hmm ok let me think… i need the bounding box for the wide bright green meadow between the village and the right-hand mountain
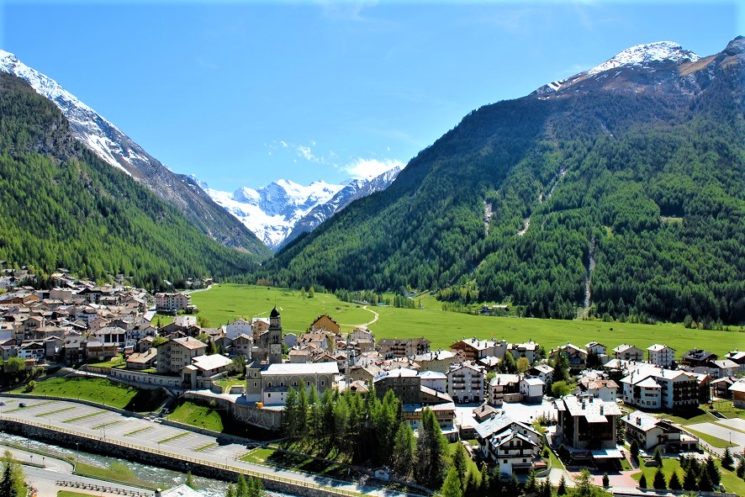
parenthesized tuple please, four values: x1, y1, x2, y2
(192, 284, 745, 356)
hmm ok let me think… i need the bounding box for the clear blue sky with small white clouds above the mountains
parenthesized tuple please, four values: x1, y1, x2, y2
(0, 0, 745, 190)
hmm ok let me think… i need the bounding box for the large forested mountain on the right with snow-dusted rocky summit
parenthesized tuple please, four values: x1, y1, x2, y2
(265, 37, 745, 322)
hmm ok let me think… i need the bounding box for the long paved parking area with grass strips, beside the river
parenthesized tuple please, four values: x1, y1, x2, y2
(0, 398, 406, 497)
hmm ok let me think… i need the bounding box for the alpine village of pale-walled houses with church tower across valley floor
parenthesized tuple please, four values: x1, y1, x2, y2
(0, 270, 745, 495)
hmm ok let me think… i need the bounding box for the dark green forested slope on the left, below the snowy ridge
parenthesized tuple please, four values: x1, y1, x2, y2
(0, 74, 255, 288)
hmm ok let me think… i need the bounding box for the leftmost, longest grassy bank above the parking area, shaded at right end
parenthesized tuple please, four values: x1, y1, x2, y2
(13, 377, 163, 412)
